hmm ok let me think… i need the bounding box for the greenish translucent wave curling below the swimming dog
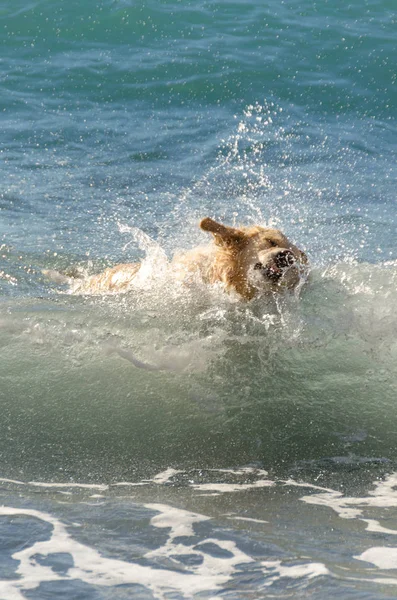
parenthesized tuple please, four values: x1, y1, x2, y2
(0, 247, 397, 480)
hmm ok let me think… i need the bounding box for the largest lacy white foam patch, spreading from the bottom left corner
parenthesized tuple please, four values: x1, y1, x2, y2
(0, 504, 329, 600)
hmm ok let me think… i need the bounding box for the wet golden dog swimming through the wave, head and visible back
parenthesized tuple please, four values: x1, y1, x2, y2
(55, 217, 308, 300)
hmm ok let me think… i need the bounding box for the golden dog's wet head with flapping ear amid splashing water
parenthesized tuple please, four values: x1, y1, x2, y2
(200, 217, 307, 300)
